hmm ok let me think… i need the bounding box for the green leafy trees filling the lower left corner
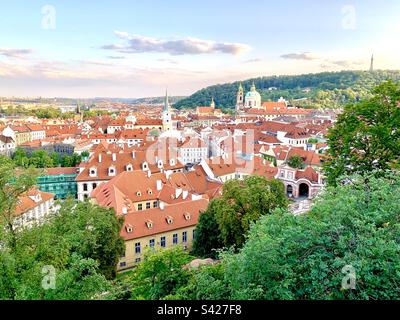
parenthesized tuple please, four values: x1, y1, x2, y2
(0, 157, 125, 299)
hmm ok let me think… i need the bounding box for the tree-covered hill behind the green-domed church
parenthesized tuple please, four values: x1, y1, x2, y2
(174, 70, 400, 109)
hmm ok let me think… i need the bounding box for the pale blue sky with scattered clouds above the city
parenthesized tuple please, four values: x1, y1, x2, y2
(0, 0, 400, 98)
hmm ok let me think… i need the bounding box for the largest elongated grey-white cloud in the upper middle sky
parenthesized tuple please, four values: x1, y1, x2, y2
(102, 31, 251, 55)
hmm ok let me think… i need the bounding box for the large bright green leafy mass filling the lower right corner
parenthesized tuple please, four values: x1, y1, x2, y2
(223, 173, 400, 300)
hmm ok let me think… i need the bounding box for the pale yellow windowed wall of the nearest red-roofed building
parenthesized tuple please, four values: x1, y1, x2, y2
(117, 226, 195, 271)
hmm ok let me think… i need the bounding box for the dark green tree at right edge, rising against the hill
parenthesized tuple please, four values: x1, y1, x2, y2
(325, 82, 400, 184)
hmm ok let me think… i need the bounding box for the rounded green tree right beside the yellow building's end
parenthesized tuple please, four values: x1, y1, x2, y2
(194, 176, 287, 252)
